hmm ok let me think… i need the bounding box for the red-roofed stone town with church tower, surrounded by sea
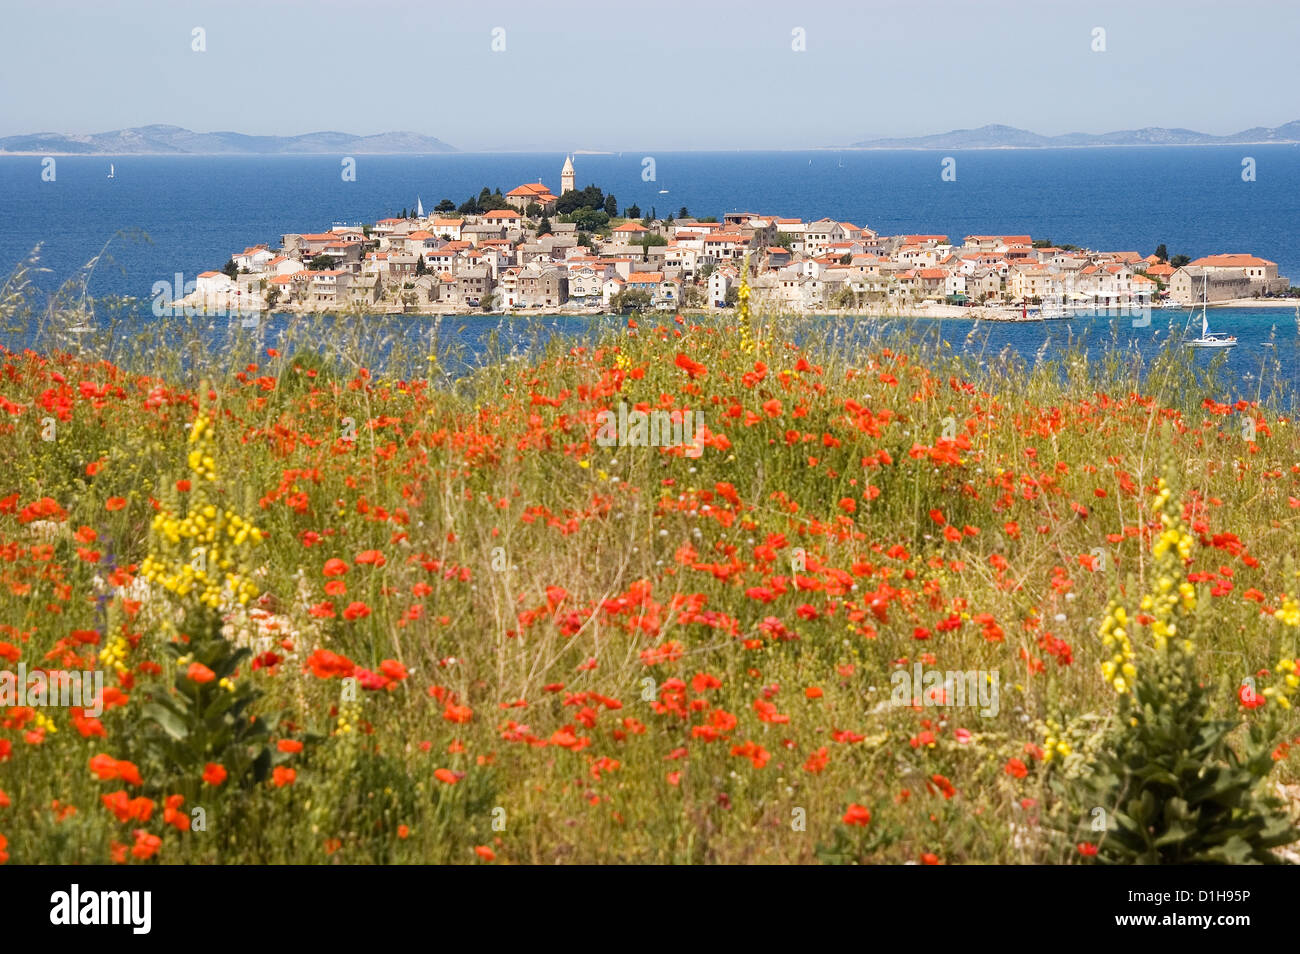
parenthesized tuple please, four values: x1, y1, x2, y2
(178, 157, 1300, 320)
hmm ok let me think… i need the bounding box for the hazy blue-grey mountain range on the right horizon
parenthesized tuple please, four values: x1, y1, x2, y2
(852, 120, 1300, 149)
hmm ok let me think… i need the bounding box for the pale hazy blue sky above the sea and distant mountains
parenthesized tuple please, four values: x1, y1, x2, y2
(0, 0, 1300, 151)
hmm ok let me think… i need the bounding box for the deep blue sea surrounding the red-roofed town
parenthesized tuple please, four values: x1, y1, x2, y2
(0, 146, 1300, 402)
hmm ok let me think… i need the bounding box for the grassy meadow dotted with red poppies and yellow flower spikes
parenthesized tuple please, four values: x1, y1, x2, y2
(0, 278, 1300, 864)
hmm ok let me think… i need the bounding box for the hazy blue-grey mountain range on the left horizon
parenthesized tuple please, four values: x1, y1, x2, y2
(0, 126, 456, 156)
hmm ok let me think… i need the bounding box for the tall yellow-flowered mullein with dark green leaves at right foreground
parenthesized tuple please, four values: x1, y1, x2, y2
(1048, 464, 1300, 864)
